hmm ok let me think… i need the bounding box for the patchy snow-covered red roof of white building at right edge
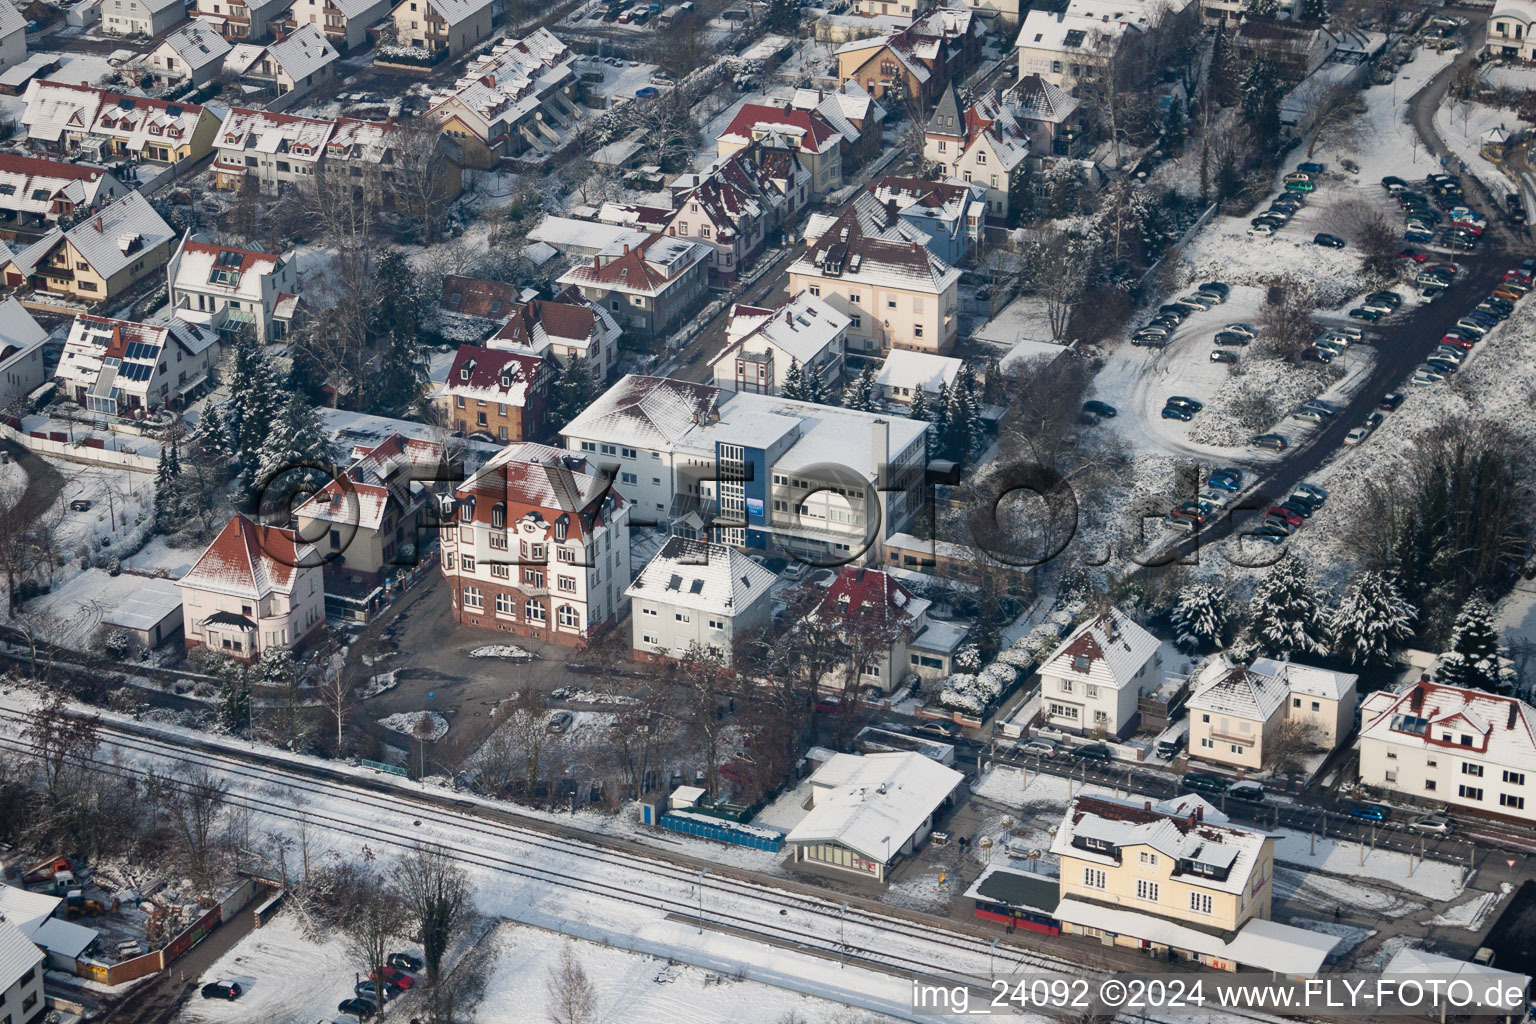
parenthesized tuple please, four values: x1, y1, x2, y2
(1359, 680, 1536, 771)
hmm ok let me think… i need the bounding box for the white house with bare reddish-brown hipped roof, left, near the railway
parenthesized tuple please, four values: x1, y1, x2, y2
(177, 513, 326, 662)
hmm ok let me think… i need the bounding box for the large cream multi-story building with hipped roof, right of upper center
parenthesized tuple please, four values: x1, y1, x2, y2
(790, 197, 960, 355)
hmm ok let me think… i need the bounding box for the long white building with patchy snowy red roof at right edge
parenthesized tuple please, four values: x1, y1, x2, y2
(1359, 679, 1536, 824)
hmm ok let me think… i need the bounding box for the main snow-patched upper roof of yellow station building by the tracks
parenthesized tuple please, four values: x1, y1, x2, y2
(1051, 797, 1269, 894)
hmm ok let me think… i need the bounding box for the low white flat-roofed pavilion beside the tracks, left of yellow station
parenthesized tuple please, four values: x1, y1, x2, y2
(785, 751, 965, 883)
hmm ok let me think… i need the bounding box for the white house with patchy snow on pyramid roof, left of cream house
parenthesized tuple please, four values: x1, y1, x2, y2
(1040, 608, 1163, 737)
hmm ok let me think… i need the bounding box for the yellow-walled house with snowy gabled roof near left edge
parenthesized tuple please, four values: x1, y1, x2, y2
(0, 192, 177, 304)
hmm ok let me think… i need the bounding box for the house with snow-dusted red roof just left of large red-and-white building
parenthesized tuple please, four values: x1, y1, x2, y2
(293, 434, 450, 583)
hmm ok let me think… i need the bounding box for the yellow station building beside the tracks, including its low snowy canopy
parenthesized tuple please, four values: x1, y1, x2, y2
(1051, 795, 1338, 976)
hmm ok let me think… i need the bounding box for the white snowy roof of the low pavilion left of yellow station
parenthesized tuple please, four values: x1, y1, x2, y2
(786, 751, 965, 864)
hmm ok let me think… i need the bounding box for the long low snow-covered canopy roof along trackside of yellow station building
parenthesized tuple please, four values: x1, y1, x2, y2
(1055, 897, 1339, 975)
